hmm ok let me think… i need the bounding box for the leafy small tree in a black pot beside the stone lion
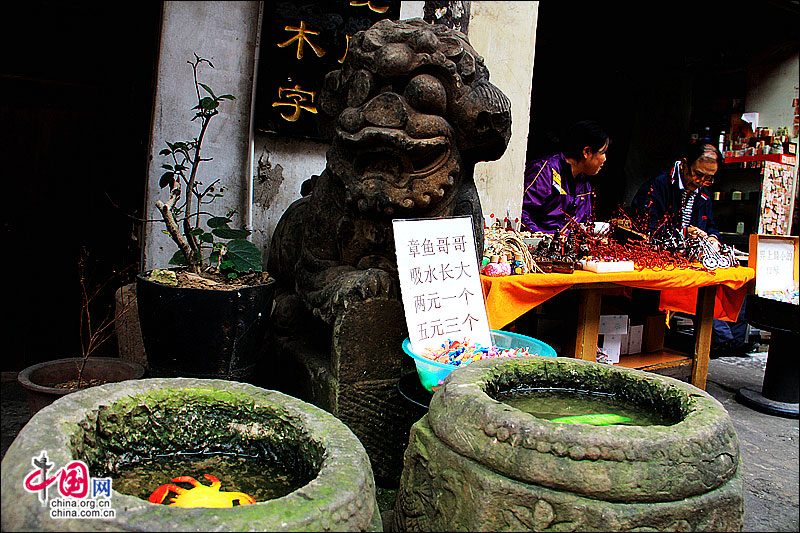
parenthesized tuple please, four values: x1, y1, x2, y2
(136, 54, 275, 380)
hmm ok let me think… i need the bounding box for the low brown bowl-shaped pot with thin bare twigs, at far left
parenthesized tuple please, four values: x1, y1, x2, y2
(17, 249, 145, 415)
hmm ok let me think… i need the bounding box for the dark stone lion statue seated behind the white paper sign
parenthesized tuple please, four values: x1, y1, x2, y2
(267, 19, 511, 324)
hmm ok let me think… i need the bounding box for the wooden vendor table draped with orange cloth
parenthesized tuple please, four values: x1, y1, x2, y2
(481, 266, 755, 389)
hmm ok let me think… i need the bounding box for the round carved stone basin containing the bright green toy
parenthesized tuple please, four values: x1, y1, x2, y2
(394, 358, 744, 531)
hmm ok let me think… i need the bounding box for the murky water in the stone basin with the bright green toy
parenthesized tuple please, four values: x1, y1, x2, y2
(495, 388, 676, 426)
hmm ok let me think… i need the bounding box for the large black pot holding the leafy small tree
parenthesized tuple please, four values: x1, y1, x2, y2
(136, 272, 276, 381)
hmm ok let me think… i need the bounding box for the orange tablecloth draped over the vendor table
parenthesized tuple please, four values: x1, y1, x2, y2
(481, 266, 755, 329)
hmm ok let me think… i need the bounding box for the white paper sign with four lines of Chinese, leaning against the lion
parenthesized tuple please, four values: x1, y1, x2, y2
(392, 216, 492, 353)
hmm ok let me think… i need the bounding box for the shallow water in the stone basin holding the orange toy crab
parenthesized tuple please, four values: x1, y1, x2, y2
(111, 454, 312, 504)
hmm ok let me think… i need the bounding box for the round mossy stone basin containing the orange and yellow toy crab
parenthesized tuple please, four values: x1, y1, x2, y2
(2, 378, 381, 531)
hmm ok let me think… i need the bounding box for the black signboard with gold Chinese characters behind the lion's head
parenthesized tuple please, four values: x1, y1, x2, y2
(255, 0, 400, 139)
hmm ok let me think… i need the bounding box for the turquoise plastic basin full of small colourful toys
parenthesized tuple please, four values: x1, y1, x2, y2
(403, 329, 557, 393)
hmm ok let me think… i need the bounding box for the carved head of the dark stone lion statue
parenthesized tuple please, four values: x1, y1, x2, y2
(319, 19, 511, 216)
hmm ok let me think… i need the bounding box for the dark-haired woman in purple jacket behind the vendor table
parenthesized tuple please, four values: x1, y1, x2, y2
(521, 120, 611, 233)
